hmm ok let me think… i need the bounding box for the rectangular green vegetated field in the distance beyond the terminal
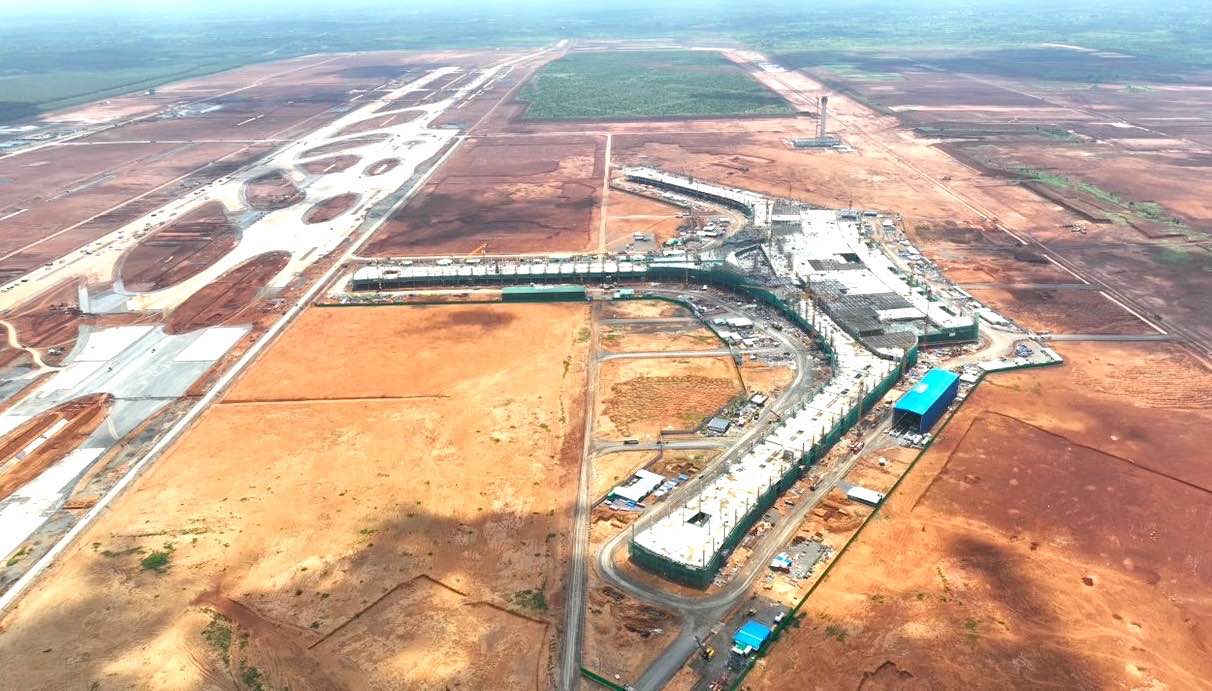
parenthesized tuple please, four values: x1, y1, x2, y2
(518, 51, 791, 120)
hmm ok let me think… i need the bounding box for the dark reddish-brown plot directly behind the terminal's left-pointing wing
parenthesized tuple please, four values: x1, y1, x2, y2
(364, 137, 604, 256)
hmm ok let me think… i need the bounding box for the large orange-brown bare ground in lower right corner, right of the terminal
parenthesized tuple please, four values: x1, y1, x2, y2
(748, 344, 1212, 690)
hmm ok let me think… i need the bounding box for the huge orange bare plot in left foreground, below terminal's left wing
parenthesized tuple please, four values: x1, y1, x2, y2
(0, 304, 588, 689)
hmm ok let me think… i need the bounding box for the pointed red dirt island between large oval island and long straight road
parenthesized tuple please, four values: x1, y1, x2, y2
(165, 252, 291, 333)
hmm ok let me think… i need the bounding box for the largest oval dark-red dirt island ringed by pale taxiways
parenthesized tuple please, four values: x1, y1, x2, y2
(121, 201, 238, 292)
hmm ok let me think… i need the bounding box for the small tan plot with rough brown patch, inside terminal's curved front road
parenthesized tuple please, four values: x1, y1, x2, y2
(594, 358, 742, 439)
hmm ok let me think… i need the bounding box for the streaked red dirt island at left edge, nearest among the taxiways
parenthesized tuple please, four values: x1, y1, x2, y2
(0, 394, 113, 499)
